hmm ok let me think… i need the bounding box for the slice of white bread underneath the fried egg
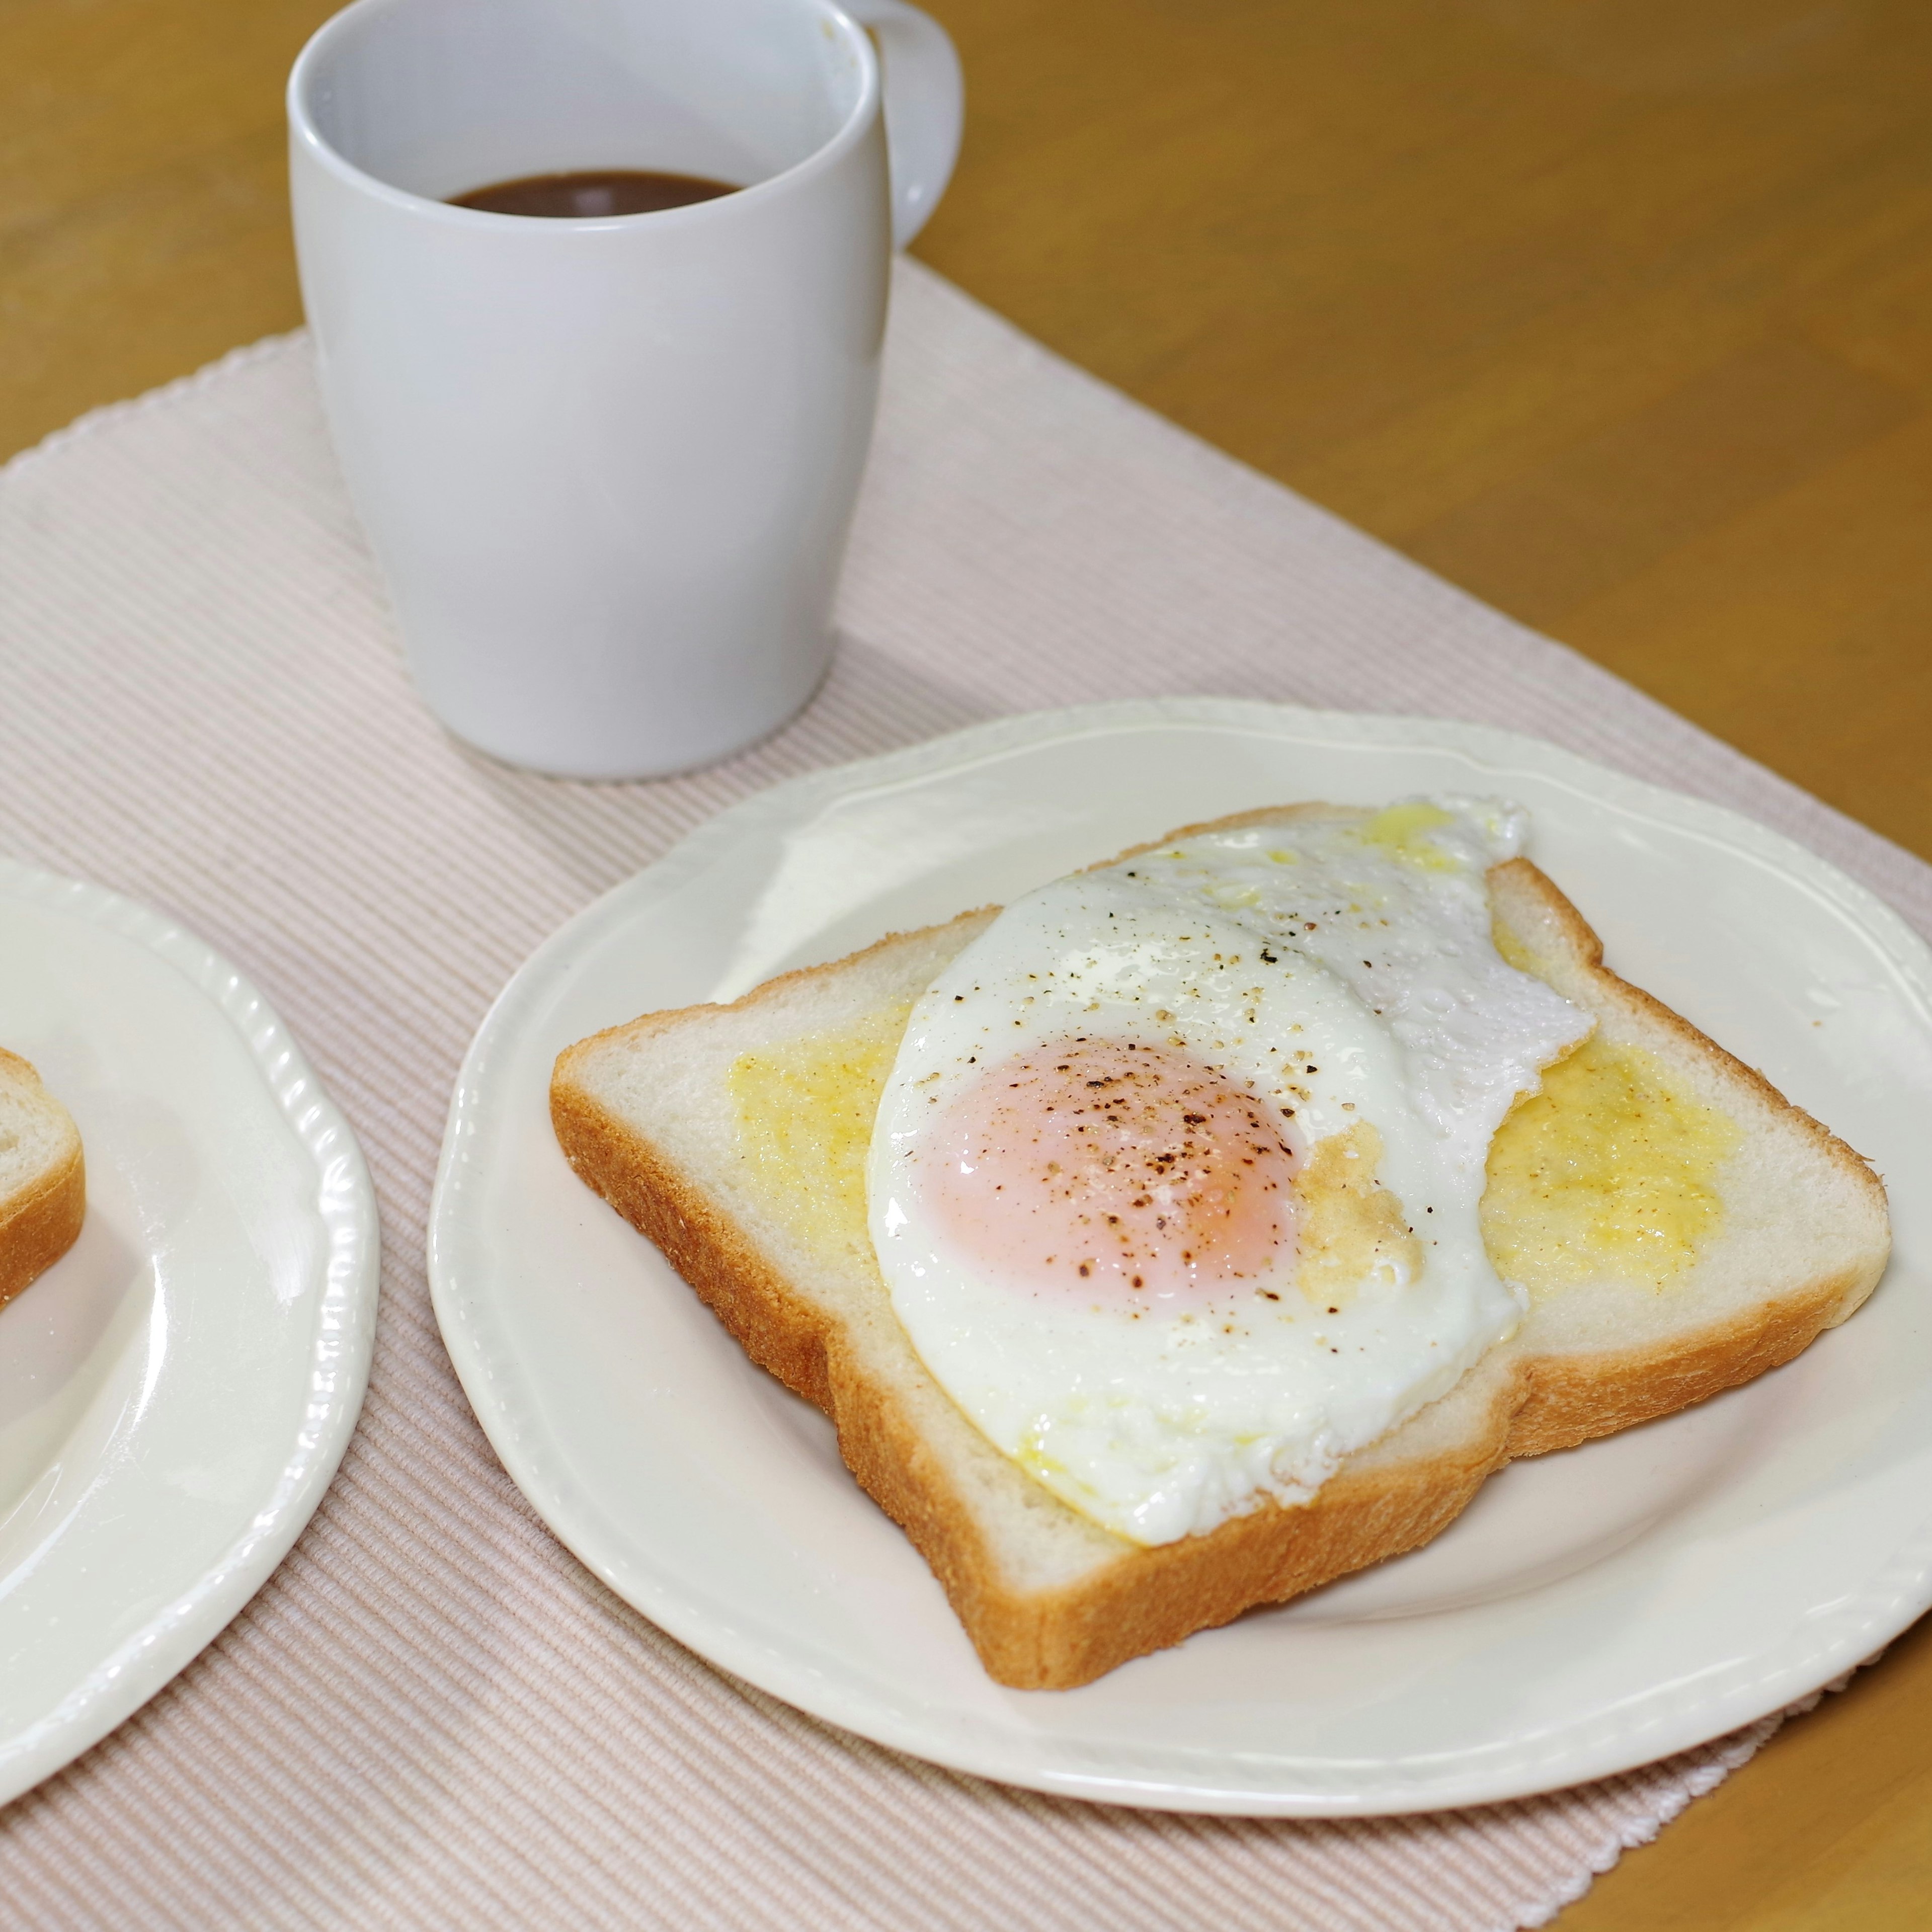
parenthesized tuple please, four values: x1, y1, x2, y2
(550, 808, 1890, 1688)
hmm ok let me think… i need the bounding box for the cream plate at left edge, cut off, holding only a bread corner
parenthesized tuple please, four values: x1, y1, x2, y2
(0, 860, 377, 1801)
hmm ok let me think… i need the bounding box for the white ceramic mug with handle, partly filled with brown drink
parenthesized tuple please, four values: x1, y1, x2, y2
(288, 0, 960, 777)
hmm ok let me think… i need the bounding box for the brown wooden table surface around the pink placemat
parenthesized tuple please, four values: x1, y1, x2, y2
(0, 0, 1932, 1932)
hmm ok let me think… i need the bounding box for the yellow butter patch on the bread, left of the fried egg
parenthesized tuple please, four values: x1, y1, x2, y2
(727, 1003, 912, 1244)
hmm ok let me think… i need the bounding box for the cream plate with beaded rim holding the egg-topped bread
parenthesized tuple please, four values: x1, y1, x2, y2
(431, 699, 1932, 1816)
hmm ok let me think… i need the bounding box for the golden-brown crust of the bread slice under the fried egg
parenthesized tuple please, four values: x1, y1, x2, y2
(550, 823, 1886, 1688)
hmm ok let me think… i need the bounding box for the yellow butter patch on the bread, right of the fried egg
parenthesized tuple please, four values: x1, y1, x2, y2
(1482, 1035, 1743, 1295)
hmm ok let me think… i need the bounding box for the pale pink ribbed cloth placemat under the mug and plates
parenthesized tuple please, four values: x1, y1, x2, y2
(0, 265, 1932, 1932)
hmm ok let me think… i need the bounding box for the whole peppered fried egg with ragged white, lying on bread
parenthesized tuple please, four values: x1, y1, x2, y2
(867, 798, 1592, 1546)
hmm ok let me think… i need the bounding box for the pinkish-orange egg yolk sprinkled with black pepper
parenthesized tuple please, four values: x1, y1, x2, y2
(920, 1039, 1298, 1304)
